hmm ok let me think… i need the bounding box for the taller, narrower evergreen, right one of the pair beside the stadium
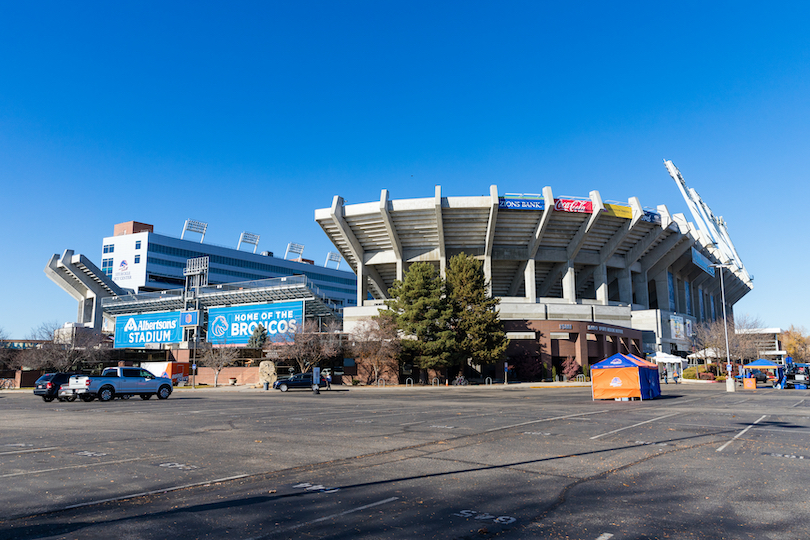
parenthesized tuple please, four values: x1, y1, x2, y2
(447, 253, 508, 365)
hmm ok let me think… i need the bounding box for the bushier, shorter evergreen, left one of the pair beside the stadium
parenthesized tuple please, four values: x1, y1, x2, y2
(386, 262, 457, 369)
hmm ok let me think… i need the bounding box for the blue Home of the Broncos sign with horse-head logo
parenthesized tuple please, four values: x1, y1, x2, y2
(208, 302, 304, 345)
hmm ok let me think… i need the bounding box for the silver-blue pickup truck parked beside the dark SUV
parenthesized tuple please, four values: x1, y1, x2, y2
(59, 367, 172, 401)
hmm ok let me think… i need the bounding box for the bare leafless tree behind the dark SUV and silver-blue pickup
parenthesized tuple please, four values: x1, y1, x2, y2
(15, 322, 109, 371)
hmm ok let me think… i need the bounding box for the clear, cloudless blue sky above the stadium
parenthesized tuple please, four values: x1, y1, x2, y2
(0, 1, 810, 337)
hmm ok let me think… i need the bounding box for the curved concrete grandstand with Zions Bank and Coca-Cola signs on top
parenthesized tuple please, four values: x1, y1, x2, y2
(315, 162, 753, 373)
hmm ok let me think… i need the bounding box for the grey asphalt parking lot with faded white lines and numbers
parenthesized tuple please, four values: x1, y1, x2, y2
(0, 385, 810, 540)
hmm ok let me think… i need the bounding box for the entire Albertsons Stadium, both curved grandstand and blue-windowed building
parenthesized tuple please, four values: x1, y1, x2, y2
(38, 162, 753, 384)
